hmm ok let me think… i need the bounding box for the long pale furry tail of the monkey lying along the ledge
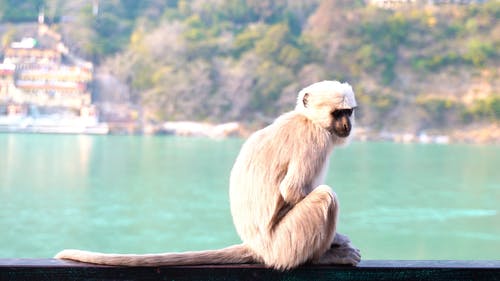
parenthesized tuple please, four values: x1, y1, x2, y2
(55, 244, 256, 266)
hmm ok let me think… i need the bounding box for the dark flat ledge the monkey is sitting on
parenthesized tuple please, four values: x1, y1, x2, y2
(0, 259, 500, 281)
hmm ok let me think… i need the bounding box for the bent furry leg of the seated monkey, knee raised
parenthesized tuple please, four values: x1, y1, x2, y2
(258, 185, 338, 269)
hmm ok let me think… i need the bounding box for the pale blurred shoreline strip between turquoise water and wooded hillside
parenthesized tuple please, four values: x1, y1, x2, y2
(0, 121, 500, 145)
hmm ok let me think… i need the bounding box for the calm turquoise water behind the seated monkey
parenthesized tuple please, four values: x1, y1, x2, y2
(0, 134, 500, 259)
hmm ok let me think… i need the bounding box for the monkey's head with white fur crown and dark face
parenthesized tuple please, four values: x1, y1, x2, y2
(295, 81, 357, 138)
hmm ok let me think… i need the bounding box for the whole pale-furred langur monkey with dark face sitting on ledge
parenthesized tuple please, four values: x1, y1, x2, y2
(56, 81, 361, 270)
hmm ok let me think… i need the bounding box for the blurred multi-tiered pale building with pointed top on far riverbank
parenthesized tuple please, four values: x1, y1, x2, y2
(0, 23, 107, 132)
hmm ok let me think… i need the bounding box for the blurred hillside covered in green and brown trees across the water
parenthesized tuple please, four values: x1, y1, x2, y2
(0, 0, 500, 142)
